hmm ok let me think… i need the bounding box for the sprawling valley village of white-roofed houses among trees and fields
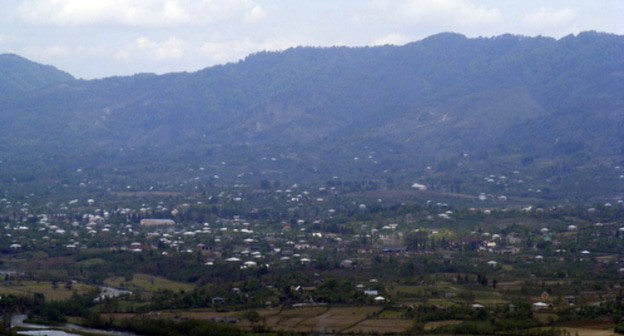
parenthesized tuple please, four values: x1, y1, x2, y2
(0, 181, 624, 333)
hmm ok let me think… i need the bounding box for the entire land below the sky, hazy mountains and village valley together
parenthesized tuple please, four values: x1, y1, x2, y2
(0, 32, 624, 336)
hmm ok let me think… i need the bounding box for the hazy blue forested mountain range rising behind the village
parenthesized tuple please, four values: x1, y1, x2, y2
(0, 32, 624, 200)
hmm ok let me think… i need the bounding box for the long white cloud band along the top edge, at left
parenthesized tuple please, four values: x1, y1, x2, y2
(17, 0, 266, 27)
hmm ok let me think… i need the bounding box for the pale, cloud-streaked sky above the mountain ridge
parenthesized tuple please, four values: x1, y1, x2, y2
(0, 0, 624, 79)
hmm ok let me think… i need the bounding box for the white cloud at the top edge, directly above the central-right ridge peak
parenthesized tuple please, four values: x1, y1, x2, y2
(399, 0, 501, 25)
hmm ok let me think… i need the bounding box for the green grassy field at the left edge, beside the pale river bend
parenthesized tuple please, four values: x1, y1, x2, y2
(0, 281, 96, 301)
